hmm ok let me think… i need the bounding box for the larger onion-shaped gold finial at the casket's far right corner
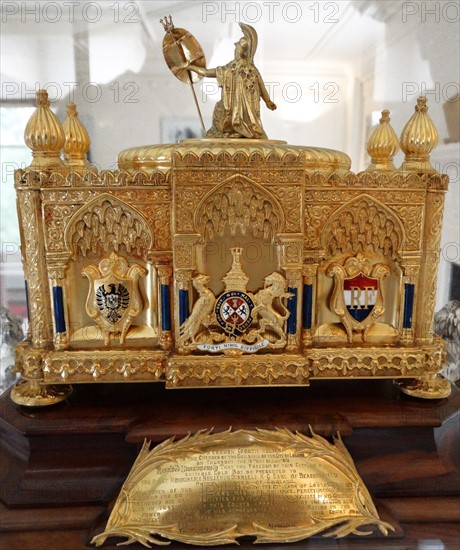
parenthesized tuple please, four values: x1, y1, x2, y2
(399, 97, 438, 172)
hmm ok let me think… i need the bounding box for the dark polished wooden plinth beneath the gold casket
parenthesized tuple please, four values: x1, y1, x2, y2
(0, 380, 460, 550)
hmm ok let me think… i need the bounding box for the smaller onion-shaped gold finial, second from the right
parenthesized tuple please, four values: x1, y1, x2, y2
(366, 109, 399, 172)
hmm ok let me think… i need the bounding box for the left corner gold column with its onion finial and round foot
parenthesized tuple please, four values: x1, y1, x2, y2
(11, 90, 72, 406)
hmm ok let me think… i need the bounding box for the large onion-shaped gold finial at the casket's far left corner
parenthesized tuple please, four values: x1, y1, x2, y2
(24, 90, 65, 168)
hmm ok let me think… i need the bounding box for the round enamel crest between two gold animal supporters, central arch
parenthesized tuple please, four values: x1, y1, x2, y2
(215, 290, 254, 336)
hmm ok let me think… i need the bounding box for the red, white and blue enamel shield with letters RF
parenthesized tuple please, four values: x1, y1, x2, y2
(343, 273, 379, 323)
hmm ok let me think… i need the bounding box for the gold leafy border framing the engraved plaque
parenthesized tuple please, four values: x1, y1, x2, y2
(91, 428, 394, 547)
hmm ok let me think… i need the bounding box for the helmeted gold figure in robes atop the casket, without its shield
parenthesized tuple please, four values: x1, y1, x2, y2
(185, 23, 276, 139)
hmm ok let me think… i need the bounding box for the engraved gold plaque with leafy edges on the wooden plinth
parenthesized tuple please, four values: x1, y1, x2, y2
(92, 429, 393, 546)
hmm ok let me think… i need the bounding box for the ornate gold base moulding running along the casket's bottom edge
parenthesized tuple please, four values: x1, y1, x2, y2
(30, 338, 444, 387)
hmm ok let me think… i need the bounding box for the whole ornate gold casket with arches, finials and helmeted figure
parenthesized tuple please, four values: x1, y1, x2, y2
(8, 18, 450, 406)
